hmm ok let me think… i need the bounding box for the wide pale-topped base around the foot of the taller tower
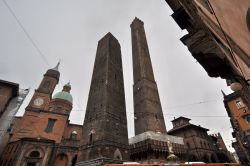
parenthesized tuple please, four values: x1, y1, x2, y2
(129, 131, 187, 164)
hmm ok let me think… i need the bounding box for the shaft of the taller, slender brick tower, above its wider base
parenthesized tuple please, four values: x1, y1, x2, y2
(130, 18, 166, 135)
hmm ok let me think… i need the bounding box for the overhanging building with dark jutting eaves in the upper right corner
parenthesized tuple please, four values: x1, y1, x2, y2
(166, 0, 250, 86)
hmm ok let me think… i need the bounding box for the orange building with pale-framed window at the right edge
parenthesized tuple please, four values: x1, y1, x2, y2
(224, 89, 250, 165)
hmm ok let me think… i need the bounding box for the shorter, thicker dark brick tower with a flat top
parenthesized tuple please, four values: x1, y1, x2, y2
(78, 33, 128, 165)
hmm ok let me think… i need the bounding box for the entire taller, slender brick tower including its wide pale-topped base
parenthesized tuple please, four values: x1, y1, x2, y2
(129, 18, 184, 163)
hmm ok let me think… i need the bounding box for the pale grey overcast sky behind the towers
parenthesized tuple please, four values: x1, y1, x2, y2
(0, 0, 233, 150)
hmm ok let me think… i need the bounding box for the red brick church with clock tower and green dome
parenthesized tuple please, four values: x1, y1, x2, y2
(0, 64, 82, 166)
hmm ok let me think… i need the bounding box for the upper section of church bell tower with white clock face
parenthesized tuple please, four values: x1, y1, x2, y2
(26, 62, 60, 111)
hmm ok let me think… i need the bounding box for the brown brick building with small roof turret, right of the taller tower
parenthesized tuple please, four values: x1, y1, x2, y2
(168, 117, 234, 163)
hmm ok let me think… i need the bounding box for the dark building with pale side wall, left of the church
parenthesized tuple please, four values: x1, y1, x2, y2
(0, 80, 29, 155)
